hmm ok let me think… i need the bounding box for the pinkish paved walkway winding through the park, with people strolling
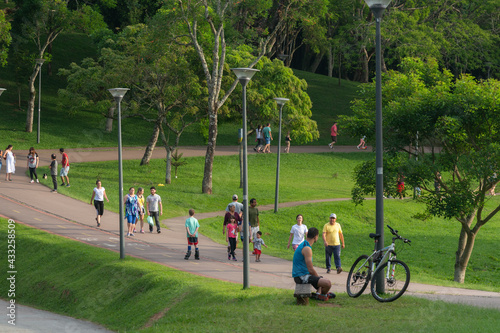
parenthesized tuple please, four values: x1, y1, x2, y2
(0, 147, 500, 332)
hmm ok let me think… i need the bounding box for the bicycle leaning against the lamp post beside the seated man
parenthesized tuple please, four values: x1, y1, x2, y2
(347, 226, 411, 302)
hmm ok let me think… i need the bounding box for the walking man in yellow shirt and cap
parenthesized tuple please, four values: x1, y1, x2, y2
(323, 214, 345, 274)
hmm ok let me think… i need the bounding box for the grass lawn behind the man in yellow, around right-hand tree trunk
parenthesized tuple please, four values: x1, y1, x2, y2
(200, 197, 500, 292)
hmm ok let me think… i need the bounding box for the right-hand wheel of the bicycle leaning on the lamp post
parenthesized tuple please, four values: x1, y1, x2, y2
(370, 260, 410, 302)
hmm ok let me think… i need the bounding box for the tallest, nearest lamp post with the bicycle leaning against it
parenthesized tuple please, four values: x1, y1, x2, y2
(365, 0, 391, 292)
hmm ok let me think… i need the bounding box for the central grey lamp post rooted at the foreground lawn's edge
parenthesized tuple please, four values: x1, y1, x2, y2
(231, 68, 259, 289)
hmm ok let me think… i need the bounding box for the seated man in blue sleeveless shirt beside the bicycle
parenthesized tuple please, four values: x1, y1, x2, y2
(292, 228, 335, 301)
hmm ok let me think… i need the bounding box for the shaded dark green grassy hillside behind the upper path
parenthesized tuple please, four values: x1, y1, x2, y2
(0, 34, 358, 149)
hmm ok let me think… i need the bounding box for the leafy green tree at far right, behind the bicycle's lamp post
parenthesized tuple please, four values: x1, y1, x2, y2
(341, 58, 500, 283)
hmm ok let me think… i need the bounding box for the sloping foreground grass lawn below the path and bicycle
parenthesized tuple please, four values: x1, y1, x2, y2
(0, 219, 500, 333)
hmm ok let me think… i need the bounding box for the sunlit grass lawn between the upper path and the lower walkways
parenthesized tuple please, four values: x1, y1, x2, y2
(34, 153, 373, 217)
